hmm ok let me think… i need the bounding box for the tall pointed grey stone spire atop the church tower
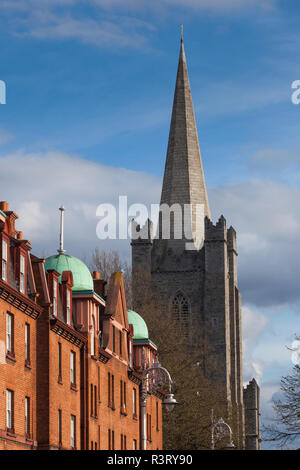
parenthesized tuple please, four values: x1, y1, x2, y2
(161, 32, 210, 228)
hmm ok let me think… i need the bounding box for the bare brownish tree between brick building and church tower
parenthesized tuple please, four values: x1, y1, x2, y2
(91, 249, 232, 450)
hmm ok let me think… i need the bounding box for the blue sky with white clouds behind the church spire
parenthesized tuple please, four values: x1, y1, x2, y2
(0, 0, 300, 448)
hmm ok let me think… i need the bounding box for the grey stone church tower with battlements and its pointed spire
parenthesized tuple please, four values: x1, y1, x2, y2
(131, 38, 260, 448)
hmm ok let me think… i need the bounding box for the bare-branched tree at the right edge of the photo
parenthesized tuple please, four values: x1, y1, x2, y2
(263, 365, 300, 447)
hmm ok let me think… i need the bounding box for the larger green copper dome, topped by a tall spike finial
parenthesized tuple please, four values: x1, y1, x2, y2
(44, 254, 94, 291)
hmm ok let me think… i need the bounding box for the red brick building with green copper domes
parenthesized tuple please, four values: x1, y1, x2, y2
(0, 202, 164, 450)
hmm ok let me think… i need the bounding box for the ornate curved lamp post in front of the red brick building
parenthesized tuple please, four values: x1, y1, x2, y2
(140, 361, 178, 450)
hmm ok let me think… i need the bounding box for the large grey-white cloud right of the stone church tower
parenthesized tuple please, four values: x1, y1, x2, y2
(209, 180, 300, 306)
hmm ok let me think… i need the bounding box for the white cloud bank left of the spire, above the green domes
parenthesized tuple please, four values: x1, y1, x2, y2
(0, 152, 161, 256)
